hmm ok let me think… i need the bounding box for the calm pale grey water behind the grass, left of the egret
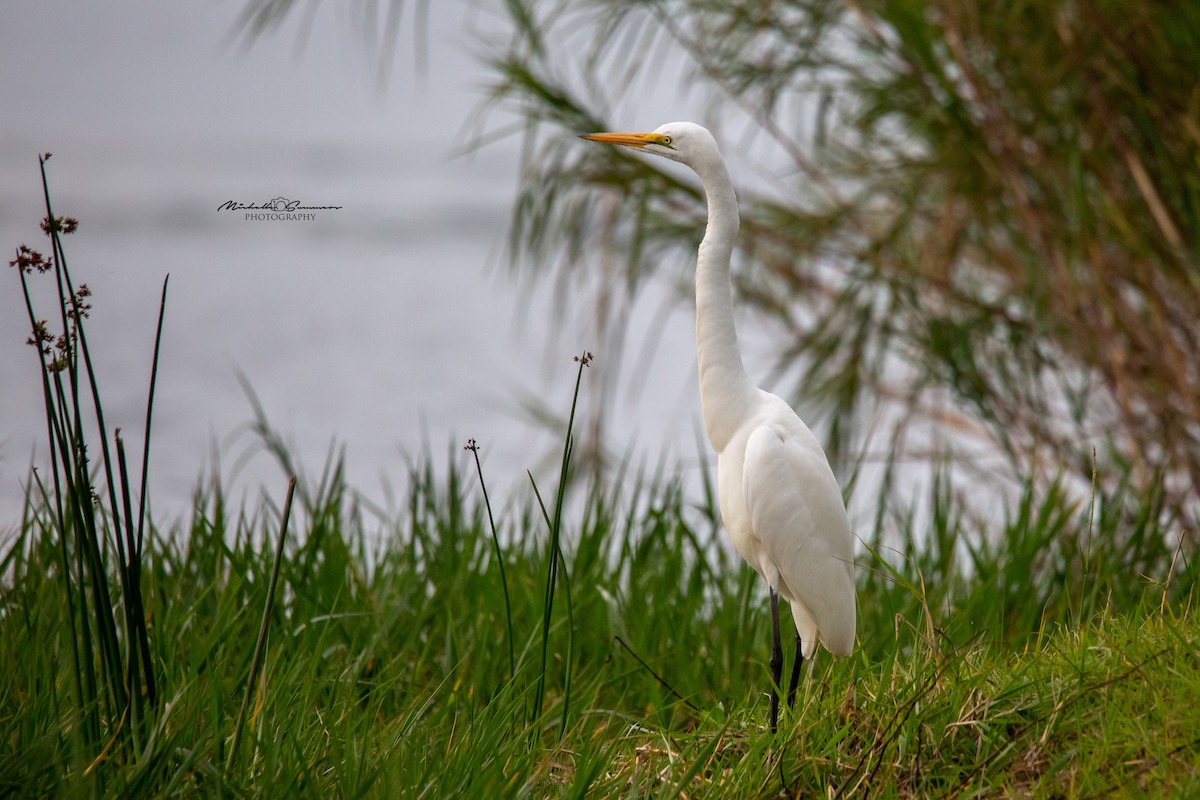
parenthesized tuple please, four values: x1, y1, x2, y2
(0, 128, 698, 527)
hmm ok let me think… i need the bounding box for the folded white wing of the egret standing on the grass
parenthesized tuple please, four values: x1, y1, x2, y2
(743, 420, 854, 655)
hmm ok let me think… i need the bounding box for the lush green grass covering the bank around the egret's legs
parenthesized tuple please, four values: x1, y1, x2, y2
(0, 441, 1200, 798)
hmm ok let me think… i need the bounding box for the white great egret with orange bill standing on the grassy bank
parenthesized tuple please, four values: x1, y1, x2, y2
(583, 122, 854, 733)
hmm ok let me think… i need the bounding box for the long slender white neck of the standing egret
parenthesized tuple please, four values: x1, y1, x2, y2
(695, 153, 757, 453)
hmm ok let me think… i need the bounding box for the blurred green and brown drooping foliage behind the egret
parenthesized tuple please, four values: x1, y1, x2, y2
(246, 0, 1200, 527)
